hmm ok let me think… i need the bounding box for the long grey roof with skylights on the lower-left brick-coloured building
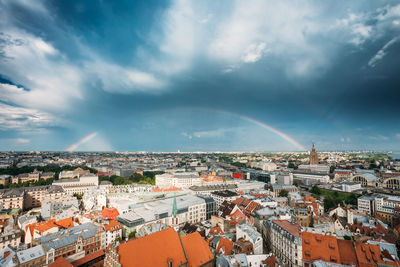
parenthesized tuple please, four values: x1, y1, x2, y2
(36, 223, 99, 250)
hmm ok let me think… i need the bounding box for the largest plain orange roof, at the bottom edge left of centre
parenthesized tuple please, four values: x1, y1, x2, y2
(118, 228, 187, 267)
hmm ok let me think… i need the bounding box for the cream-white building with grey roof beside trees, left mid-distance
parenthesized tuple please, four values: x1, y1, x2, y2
(53, 175, 99, 194)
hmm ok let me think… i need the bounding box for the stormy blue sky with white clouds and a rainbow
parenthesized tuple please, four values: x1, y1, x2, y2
(0, 0, 400, 151)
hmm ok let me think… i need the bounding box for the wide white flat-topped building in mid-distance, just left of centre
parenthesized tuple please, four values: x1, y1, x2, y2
(156, 172, 201, 188)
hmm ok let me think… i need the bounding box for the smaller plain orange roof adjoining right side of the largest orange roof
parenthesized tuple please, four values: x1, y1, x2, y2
(182, 232, 214, 266)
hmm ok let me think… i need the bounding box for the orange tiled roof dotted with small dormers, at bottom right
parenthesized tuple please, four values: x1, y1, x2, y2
(301, 232, 341, 264)
